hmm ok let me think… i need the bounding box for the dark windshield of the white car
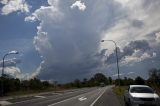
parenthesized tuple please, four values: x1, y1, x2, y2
(130, 87, 153, 93)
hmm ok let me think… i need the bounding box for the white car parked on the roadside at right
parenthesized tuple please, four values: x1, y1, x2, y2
(124, 85, 160, 106)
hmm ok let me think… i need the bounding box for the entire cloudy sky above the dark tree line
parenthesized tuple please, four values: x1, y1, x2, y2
(0, 0, 160, 82)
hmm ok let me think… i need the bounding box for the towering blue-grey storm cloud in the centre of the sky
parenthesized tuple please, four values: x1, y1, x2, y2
(26, 0, 125, 81)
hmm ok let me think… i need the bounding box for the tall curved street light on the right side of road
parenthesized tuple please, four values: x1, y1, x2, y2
(101, 40, 120, 86)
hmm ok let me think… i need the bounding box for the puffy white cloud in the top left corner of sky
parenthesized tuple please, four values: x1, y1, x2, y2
(0, 0, 29, 15)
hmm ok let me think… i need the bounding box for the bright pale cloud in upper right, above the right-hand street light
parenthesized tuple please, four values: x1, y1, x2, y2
(104, 0, 160, 48)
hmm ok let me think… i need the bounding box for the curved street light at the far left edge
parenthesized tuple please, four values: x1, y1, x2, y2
(1, 51, 19, 96)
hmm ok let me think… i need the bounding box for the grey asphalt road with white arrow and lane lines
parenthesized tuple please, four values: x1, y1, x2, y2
(0, 86, 121, 106)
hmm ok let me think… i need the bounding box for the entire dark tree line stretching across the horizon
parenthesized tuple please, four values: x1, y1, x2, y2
(0, 68, 160, 94)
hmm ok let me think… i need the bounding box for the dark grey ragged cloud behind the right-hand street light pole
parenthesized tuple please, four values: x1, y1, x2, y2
(105, 40, 153, 64)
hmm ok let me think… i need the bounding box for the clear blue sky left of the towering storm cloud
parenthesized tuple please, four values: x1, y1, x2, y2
(0, 0, 47, 73)
